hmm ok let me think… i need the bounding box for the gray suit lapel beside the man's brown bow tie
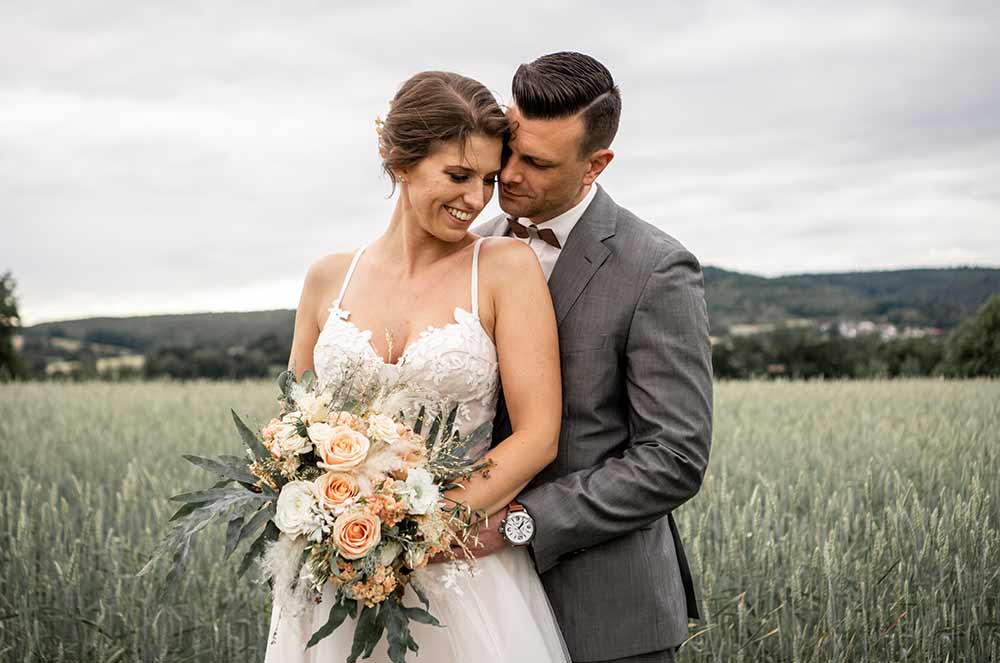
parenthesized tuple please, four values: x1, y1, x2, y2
(549, 185, 618, 324)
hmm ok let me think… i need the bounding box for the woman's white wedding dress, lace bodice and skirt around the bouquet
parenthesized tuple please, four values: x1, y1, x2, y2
(265, 239, 570, 663)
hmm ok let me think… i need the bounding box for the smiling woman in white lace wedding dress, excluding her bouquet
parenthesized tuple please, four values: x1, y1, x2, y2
(266, 72, 569, 663)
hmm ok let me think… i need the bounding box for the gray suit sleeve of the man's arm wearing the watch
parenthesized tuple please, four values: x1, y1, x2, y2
(518, 249, 712, 573)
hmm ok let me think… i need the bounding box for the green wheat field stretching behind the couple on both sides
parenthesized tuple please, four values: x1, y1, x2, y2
(0, 380, 1000, 663)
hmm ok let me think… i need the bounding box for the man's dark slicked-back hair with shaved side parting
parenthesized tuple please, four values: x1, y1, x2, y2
(511, 51, 622, 157)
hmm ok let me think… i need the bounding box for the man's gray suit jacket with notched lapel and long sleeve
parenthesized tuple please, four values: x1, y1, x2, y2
(474, 189, 712, 661)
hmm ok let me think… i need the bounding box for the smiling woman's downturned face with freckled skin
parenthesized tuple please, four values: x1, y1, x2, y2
(400, 135, 503, 242)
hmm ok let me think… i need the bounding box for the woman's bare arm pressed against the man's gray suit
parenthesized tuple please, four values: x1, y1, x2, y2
(446, 238, 562, 514)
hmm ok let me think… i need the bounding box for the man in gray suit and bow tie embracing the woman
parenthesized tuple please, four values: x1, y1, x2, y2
(474, 53, 712, 663)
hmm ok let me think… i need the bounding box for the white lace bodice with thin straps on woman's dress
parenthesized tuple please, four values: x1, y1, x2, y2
(313, 238, 500, 452)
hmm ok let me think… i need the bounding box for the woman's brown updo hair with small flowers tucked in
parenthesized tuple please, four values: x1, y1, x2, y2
(376, 71, 511, 191)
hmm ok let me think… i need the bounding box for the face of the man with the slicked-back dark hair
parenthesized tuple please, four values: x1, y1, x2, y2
(500, 105, 590, 223)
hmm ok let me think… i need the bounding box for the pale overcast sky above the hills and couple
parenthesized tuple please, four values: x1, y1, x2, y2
(0, 0, 1000, 325)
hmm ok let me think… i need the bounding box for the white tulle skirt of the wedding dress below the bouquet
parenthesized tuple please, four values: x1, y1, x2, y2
(265, 548, 570, 663)
